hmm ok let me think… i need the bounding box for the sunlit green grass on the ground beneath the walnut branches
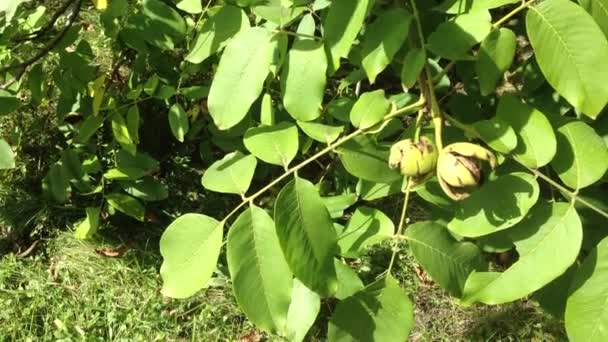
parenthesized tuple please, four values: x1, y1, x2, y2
(0, 227, 565, 341)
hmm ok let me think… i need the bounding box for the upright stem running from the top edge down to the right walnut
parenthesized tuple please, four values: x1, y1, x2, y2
(410, 0, 443, 151)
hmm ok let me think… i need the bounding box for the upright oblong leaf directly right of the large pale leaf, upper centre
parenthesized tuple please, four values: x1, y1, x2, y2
(281, 39, 327, 121)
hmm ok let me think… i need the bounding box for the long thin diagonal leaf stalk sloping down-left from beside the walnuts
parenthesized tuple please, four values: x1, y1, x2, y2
(222, 97, 426, 223)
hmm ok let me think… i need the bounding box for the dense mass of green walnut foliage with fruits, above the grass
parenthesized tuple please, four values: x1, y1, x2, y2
(0, 0, 608, 341)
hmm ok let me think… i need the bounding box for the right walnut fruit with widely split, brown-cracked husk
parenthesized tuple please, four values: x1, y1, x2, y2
(437, 143, 496, 201)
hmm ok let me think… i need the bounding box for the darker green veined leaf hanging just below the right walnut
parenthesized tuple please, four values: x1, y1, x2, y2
(405, 221, 488, 297)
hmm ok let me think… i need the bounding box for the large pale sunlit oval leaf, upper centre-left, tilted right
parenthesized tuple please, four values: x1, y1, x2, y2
(208, 27, 276, 130)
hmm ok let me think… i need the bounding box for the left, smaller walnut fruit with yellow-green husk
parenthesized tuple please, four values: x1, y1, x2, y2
(388, 137, 439, 181)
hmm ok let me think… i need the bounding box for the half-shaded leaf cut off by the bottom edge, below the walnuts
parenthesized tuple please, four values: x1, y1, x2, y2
(327, 275, 414, 342)
